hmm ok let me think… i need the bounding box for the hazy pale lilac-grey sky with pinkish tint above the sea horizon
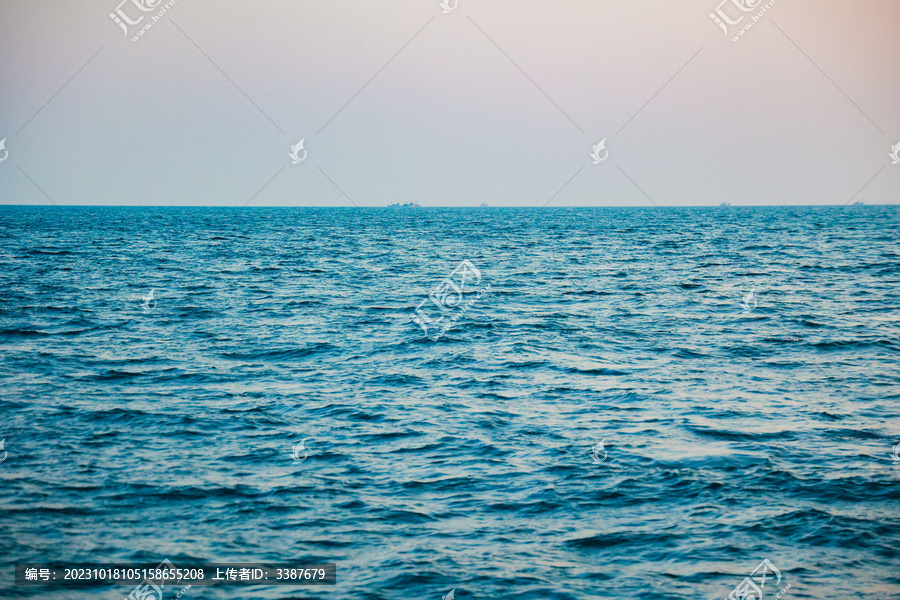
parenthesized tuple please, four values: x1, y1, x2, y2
(0, 0, 900, 207)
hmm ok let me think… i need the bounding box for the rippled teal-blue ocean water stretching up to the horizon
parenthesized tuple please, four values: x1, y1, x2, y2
(0, 206, 900, 600)
